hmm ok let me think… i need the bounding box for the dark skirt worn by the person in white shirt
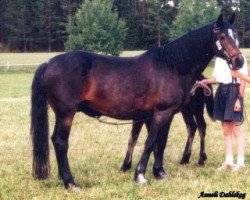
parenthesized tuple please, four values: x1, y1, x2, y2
(213, 84, 243, 122)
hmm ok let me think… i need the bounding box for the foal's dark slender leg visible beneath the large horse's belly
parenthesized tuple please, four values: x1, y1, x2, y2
(120, 122, 143, 172)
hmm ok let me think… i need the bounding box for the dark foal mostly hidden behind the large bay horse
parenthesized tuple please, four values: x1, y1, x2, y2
(121, 75, 214, 172)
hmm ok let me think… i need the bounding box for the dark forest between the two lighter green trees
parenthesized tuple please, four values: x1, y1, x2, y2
(114, 0, 178, 49)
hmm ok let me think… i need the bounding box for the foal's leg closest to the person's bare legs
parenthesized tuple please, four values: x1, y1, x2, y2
(195, 114, 207, 166)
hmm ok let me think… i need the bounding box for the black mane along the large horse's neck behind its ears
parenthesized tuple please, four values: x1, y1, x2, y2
(147, 23, 214, 73)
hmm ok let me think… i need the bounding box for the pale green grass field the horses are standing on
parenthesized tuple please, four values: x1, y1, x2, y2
(0, 49, 250, 200)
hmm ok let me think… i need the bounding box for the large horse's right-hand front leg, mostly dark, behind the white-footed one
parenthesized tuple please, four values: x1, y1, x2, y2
(153, 117, 173, 179)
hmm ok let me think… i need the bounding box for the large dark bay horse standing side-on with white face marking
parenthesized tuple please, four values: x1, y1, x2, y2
(31, 15, 244, 189)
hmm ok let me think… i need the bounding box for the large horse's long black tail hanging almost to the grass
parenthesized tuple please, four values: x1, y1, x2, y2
(30, 63, 50, 179)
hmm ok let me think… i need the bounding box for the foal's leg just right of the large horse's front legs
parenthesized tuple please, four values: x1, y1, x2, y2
(180, 108, 197, 165)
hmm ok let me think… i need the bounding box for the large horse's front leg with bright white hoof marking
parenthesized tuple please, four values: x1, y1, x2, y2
(135, 111, 172, 184)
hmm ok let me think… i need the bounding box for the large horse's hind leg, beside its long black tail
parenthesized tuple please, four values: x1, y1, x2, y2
(52, 114, 77, 190)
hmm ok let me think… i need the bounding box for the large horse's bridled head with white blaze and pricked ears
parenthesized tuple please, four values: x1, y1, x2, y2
(213, 14, 244, 70)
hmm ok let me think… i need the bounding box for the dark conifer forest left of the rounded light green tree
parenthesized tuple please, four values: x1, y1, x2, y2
(0, 0, 82, 52)
